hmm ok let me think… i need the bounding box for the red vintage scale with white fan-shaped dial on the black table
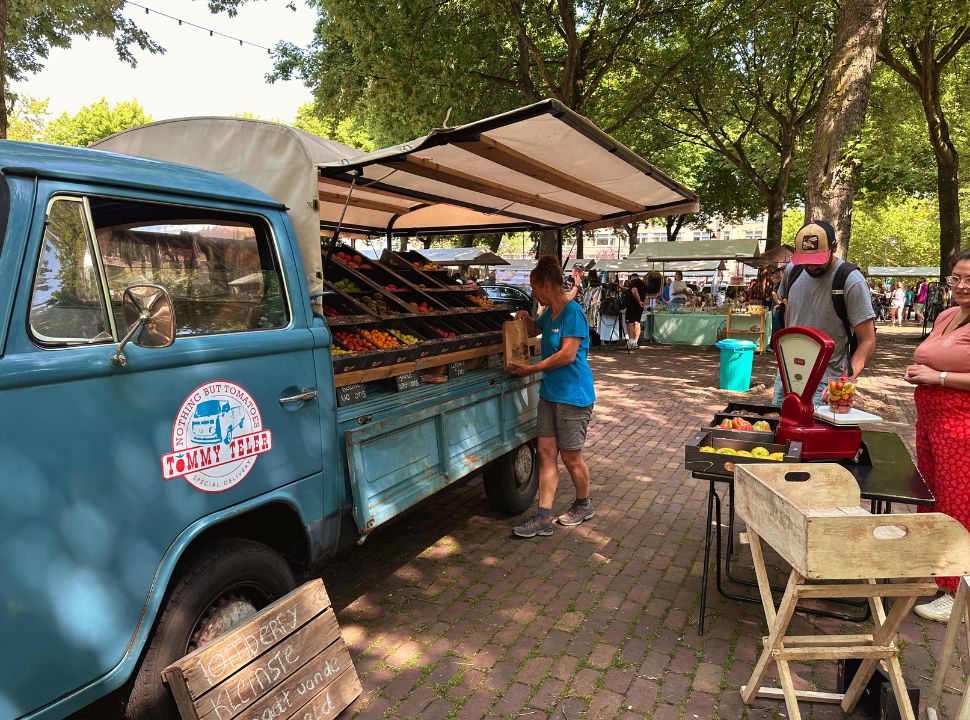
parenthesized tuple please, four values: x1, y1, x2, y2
(774, 326, 862, 460)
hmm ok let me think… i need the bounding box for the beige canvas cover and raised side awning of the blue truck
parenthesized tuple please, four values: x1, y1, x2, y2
(94, 100, 698, 290)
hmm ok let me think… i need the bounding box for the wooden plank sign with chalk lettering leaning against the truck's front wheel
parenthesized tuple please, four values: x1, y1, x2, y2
(162, 580, 361, 720)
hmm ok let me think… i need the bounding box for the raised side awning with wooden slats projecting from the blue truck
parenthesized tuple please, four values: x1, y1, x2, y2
(319, 100, 698, 235)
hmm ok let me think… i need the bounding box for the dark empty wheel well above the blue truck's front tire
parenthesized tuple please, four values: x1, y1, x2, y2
(180, 503, 310, 577)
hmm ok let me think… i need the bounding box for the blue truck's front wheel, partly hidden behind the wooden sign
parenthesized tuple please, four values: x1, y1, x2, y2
(125, 538, 295, 720)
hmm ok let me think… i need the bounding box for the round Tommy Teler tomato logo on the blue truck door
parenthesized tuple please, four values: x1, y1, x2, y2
(162, 380, 273, 492)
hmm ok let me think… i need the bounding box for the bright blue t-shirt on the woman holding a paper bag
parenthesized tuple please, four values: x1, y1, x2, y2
(536, 302, 596, 407)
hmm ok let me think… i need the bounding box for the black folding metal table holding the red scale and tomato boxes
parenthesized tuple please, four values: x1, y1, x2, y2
(691, 430, 936, 635)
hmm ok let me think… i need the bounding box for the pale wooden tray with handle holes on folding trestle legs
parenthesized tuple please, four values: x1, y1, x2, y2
(734, 463, 970, 720)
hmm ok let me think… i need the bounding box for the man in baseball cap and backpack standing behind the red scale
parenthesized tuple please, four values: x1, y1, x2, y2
(773, 220, 876, 405)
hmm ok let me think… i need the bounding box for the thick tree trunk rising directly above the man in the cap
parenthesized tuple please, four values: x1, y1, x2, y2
(805, 0, 888, 254)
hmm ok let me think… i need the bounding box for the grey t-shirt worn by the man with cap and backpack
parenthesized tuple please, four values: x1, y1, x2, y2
(778, 260, 876, 380)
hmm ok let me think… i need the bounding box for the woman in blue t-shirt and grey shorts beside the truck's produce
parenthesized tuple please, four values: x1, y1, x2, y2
(509, 255, 596, 537)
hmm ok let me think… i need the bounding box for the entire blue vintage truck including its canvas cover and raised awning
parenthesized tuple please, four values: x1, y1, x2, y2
(0, 100, 697, 720)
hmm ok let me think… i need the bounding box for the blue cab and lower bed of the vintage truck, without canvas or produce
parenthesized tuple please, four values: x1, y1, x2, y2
(0, 142, 537, 720)
